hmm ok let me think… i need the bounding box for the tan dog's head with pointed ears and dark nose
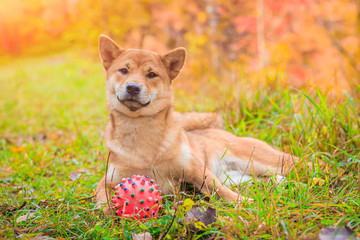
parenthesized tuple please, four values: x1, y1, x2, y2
(99, 35, 186, 117)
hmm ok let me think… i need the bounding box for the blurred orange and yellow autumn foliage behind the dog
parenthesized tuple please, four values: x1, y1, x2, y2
(0, 0, 360, 95)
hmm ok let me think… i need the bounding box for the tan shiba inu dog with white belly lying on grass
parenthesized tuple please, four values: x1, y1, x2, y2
(96, 35, 298, 211)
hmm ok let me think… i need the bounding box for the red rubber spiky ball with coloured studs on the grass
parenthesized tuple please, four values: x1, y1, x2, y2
(112, 175, 162, 220)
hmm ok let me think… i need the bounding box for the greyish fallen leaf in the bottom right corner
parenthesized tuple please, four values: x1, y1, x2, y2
(319, 227, 358, 240)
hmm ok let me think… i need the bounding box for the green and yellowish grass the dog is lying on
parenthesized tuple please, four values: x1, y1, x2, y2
(0, 51, 360, 239)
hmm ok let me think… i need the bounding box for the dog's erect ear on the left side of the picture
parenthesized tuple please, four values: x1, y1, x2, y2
(99, 34, 125, 70)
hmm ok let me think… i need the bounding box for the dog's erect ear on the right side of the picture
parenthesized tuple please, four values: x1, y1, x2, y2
(163, 47, 186, 81)
